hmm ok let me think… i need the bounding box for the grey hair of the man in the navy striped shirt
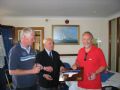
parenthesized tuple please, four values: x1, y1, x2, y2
(20, 27, 34, 40)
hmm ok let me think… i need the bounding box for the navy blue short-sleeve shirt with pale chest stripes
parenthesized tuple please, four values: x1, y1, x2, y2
(8, 44, 36, 88)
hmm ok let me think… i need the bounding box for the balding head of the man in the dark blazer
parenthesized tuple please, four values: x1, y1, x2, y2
(43, 38, 54, 51)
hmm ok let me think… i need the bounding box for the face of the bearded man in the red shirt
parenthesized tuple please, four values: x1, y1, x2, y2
(82, 34, 92, 48)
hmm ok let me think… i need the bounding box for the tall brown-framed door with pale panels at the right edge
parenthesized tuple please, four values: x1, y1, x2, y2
(109, 18, 120, 72)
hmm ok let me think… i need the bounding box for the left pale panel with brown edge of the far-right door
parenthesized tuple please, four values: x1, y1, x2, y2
(109, 19, 117, 71)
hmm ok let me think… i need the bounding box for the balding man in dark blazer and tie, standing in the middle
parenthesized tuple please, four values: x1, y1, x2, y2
(36, 38, 64, 90)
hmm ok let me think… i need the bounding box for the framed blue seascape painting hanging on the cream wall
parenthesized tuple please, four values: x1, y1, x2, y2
(52, 25, 80, 45)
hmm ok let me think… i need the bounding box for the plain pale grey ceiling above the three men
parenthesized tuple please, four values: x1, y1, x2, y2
(0, 0, 120, 17)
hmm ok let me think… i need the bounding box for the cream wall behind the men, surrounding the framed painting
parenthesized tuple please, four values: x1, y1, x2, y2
(1, 17, 108, 64)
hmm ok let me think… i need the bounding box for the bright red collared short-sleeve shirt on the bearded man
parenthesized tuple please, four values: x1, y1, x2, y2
(76, 46, 107, 89)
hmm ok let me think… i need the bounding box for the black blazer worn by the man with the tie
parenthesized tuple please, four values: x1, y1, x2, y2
(36, 50, 63, 88)
